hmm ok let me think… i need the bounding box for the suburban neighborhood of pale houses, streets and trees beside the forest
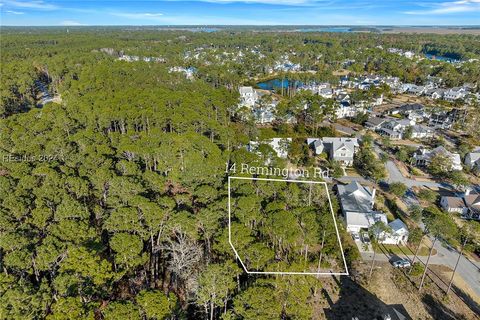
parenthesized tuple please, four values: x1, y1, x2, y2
(236, 42, 480, 316)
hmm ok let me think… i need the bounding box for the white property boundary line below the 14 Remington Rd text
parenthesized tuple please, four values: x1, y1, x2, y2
(228, 176, 349, 276)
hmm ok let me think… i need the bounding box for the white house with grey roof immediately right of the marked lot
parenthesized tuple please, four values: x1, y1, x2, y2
(337, 181, 388, 233)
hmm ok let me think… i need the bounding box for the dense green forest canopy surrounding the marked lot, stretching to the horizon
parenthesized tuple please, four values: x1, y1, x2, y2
(0, 27, 480, 319)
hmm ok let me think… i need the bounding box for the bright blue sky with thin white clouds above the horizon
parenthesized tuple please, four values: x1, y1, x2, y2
(0, 0, 480, 26)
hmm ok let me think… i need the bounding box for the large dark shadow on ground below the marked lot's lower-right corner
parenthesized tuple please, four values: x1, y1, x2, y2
(322, 276, 412, 320)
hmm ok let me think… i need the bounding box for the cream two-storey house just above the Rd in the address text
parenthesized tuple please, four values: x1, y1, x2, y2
(307, 137, 359, 166)
